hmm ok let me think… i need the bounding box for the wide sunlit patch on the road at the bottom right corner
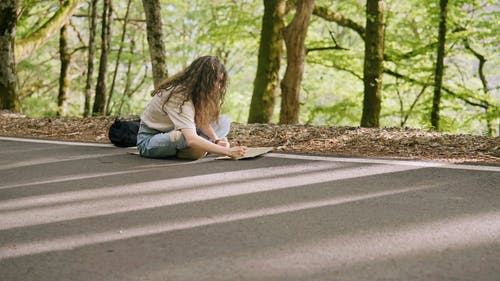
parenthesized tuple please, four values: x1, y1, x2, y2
(146, 211, 500, 280)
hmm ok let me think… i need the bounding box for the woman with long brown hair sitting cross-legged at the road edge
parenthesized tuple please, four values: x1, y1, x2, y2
(137, 56, 246, 160)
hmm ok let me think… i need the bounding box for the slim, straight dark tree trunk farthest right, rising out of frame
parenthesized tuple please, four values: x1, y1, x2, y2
(431, 0, 448, 131)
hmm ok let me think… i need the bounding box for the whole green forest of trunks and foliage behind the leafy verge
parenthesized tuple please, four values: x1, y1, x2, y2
(0, 0, 500, 136)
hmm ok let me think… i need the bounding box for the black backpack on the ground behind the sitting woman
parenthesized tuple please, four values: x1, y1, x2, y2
(108, 118, 141, 147)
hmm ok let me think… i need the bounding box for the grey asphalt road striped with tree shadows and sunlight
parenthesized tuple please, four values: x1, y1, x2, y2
(0, 138, 500, 281)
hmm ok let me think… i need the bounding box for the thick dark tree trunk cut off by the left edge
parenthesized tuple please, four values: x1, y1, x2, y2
(0, 0, 20, 112)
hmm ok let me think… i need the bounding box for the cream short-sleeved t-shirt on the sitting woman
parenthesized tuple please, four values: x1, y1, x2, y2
(141, 90, 196, 132)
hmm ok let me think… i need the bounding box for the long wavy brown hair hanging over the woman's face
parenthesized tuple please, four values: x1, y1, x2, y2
(151, 56, 228, 127)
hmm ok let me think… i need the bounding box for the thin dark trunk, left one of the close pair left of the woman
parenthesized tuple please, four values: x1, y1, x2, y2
(83, 0, 98, 117)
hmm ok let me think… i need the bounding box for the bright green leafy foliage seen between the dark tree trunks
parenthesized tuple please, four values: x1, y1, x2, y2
(13, 0, 500, 134)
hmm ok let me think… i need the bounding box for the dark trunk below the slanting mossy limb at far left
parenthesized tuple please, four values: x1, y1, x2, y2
(57, 18, 71, 116)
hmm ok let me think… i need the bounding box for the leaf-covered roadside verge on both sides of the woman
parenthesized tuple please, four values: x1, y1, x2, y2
(0, 112, 500, 165)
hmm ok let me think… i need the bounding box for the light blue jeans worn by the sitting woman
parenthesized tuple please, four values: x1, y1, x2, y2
(137, 115, 231, 158)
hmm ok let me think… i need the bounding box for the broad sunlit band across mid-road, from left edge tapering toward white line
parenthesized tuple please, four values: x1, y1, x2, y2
(0, 162, 416, 229)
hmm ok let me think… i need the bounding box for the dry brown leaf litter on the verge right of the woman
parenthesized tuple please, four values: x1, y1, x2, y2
(231, 124, 500, 164)
